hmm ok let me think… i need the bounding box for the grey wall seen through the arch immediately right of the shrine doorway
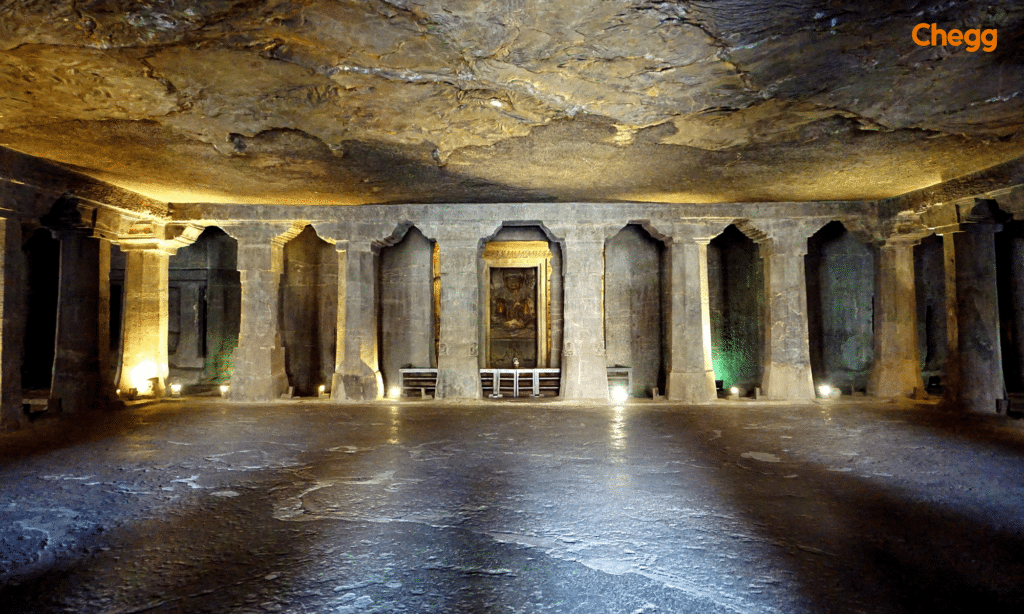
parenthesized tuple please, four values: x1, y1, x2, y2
(604, 224, 665, 397)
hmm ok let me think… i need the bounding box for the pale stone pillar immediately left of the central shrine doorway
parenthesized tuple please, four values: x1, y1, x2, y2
(437, 232, 482, 399)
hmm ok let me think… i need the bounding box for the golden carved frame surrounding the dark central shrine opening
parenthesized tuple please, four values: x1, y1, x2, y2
(483, 240, 552, 368)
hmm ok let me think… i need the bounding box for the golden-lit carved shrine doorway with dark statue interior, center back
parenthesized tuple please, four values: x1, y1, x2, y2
(483, 240, 552, 368)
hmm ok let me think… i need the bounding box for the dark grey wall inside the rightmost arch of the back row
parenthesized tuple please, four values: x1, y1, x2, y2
(805, 222, 874, 394)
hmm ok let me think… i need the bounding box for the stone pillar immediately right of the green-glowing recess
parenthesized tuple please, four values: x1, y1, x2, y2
(761, 226, 814, 400)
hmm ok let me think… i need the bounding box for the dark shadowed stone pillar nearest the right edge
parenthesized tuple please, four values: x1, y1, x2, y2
(944, 210, 1007, 413)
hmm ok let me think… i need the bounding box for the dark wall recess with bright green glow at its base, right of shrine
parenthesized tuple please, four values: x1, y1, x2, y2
(708, 225, 765, 391)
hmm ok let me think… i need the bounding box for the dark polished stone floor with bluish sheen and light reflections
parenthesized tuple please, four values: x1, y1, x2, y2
(0, 400, 1024, 614)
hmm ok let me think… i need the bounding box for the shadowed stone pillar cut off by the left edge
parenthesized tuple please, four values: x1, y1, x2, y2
(0, 218, 27, 433)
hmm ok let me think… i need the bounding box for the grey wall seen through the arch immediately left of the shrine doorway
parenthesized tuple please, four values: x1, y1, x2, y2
(378, 227, 437, 390)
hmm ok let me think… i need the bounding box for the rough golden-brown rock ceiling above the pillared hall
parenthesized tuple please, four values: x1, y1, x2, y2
(0, 0, 1024, 204)
